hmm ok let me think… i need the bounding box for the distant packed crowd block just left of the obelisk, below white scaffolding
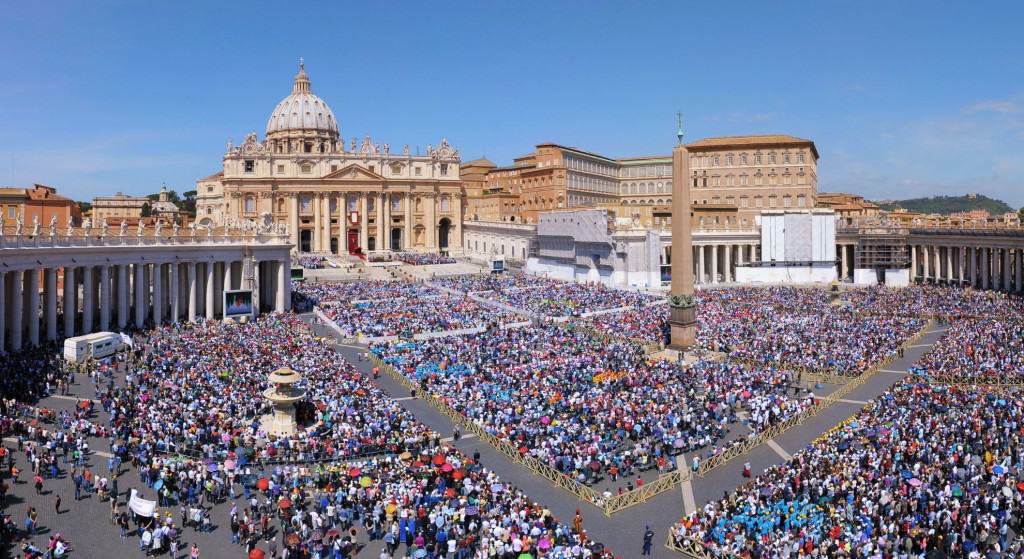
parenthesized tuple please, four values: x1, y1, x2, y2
(436, 273, 659, 316)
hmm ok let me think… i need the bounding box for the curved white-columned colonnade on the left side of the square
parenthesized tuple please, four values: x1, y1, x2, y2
(0, 221, 292, 351)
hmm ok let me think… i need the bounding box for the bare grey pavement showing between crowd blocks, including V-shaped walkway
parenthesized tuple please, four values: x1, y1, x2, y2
(0, 313, 942, 559)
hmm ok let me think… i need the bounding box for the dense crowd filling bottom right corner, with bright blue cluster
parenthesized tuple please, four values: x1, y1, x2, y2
(672, 381, 1024, 558)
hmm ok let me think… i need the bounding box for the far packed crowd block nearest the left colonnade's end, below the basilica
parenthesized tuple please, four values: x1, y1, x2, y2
(296, 281, 516, 338)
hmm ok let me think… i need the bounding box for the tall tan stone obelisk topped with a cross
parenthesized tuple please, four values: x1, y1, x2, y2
(669, 114, 697, 352)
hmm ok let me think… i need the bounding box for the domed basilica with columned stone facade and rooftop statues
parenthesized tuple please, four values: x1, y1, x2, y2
(196, 62, 464, 254)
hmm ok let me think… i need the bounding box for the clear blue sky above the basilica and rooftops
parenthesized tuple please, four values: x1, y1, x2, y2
(0, 0, 1024, 207)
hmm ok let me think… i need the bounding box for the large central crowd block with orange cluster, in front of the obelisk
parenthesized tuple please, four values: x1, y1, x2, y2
(371, 326, 812, 484)
